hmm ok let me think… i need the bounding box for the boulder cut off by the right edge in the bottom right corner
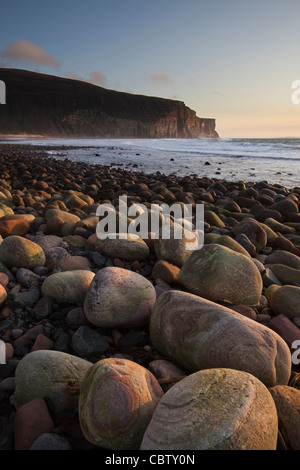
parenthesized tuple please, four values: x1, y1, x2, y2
(269, 385, 300, 450)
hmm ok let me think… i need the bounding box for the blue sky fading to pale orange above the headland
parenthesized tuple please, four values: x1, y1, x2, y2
(0, 0, 300, 138)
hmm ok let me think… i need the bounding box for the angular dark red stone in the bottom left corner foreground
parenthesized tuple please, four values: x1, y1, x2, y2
(15, 398, 54, 450)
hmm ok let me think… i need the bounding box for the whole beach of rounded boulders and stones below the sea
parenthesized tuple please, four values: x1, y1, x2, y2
(0, 144, 300, 451)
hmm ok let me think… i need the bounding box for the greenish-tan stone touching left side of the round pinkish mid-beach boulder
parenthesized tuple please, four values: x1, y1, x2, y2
(42, 270, 95, 304)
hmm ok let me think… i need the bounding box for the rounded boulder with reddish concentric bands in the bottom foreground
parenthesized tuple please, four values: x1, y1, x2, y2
(79, 358, 163, 450)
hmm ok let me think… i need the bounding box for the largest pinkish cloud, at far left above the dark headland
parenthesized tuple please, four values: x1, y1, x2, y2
(0, 41, 60, 68)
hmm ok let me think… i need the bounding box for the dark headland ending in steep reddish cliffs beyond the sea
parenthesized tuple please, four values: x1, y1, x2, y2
(0, 68, 219, 138)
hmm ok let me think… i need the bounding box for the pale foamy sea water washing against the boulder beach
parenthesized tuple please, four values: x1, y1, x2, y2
(0, 138, 300, 188)
